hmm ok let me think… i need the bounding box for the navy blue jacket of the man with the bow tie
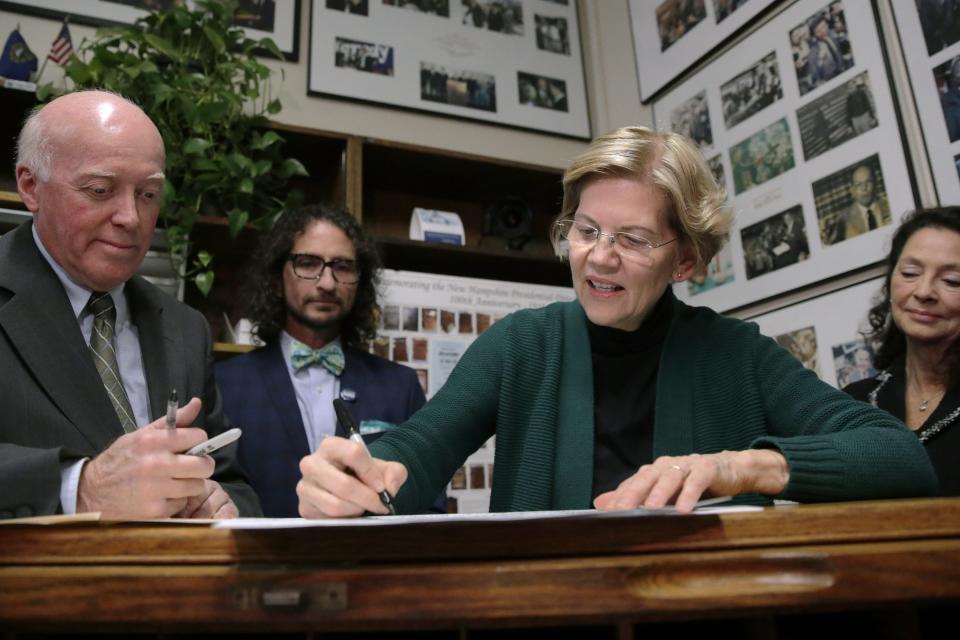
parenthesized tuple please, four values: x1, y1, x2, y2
(216, 342, 446, 518)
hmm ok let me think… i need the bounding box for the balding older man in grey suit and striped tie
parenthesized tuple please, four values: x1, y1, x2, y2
(0, 91, 259, 519)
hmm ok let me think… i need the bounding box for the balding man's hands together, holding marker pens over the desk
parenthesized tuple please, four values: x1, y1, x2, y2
(77, 398, 236, 520)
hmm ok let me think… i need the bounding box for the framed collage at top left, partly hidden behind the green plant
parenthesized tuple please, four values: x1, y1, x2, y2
(0, 0, 300, 61)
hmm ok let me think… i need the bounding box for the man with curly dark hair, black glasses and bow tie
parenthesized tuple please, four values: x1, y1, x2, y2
(216, 205, 446, 518)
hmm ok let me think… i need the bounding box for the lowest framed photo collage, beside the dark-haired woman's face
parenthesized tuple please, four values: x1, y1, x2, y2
(751, 278, 883, 389)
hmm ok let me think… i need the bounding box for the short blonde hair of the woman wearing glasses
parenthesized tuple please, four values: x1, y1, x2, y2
(551, 127, 733, 271)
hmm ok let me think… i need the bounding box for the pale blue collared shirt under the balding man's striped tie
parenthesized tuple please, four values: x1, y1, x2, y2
(32, 225, 150, 514)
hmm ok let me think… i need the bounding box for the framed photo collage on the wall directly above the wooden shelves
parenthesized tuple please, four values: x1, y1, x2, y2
(308, 0, 590, 139)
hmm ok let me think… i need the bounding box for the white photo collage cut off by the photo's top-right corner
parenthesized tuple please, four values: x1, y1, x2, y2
(893, 0, 960, 205)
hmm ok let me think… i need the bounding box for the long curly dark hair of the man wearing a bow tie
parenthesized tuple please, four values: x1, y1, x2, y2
(244, 205, 381, 347)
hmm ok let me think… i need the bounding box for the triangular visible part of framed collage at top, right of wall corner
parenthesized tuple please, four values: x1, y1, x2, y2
(629, 0, 775, 102)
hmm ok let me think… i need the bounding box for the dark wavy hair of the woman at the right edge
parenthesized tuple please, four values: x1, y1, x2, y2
(865, 207, 960, 384)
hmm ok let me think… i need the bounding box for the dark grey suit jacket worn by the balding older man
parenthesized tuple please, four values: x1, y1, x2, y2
(0, 222, 260, 518)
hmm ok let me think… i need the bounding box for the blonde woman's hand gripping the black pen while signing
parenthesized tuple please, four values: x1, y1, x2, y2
(297, 437, 407, 518)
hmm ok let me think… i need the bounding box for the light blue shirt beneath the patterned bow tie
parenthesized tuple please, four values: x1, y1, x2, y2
(280, 331, 340, 452)
